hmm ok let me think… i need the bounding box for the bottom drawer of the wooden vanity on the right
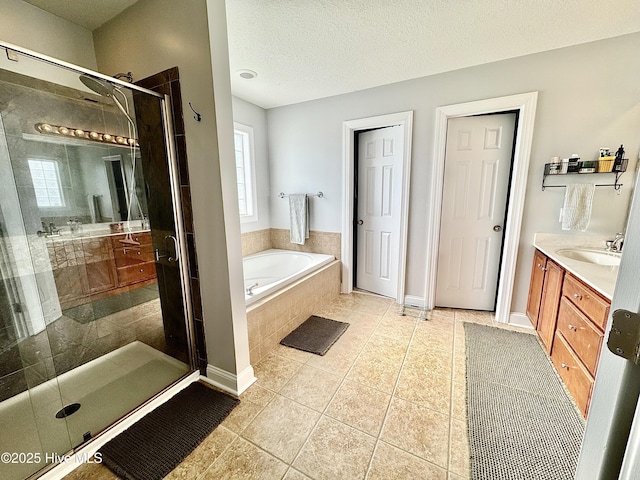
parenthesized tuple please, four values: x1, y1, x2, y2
(551, 333, 593, 417)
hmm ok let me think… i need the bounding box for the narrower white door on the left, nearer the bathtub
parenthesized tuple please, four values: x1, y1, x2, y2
(355, 126, 404, 298)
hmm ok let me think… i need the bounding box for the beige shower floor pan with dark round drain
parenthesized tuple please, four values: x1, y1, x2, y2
(0, 341, 190, 480)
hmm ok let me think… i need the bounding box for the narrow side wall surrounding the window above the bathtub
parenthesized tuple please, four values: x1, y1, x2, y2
(232, 97, 271, 233)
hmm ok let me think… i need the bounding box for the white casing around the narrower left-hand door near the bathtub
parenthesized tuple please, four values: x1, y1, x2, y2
(341, 111, 413, 304)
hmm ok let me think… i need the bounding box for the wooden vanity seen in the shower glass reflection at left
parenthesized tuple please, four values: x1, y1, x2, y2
(47, 230, 156, 310)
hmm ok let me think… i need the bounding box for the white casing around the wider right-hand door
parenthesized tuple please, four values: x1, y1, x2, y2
(424, 92, 538, 323)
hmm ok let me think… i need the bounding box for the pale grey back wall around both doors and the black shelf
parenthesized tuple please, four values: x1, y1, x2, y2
(267, 34, 640, 312)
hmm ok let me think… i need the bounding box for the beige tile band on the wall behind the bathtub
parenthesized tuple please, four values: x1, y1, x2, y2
(242, 228, 341, 260)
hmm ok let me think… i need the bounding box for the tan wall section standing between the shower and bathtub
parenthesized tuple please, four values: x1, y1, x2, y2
(94, 0, 249, 384)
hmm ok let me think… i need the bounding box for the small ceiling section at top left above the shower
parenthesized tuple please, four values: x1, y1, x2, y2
(24, 0, 138, 30)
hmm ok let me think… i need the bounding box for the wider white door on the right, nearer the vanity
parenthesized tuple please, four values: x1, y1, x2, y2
(436, 113, 516, 311)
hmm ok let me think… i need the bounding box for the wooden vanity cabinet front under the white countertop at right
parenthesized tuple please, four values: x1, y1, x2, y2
(527, 250, 611, 417)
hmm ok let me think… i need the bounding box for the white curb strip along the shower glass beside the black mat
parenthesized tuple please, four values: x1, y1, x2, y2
(38, 371, 200, 480)
